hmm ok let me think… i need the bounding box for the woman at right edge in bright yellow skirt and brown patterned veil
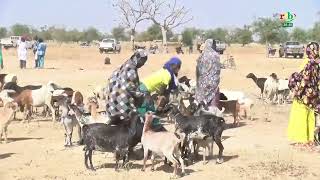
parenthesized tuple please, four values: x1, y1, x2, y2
(287, 42, 320, 149)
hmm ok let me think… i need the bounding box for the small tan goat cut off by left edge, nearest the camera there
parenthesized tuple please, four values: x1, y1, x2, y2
(0, 102, 18, 143)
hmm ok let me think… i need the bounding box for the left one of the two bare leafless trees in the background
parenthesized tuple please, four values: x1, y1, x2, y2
(113, 0, 150, 48)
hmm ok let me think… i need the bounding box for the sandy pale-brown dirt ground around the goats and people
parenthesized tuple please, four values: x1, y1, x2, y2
(0, 45, 320, 180)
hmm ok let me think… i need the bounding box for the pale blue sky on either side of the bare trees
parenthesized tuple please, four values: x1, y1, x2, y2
(0, 0, 320, 32)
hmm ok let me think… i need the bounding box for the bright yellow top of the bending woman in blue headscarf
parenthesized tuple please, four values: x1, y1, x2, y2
(141, 69, 171, 93)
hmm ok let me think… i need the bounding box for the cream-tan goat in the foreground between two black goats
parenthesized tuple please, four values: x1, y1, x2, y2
(141, 112, 185, 178)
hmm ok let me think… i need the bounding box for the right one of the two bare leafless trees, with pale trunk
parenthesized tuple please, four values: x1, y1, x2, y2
(147, 0, 193, 50)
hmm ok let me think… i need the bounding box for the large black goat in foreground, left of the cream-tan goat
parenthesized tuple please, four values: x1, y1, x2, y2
(78, 109, 139, 170)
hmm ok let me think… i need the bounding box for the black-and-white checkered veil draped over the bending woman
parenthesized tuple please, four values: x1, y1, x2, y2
(106, 50, 148, 119)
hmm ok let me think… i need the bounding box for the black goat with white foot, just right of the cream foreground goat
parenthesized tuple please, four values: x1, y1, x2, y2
(170, 104, 225, 164)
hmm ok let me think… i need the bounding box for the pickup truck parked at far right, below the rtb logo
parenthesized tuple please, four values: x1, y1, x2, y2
(279, 41, 304, 58)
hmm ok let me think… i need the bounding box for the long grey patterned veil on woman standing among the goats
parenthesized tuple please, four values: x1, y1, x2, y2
(196, 39, 221, 103)
